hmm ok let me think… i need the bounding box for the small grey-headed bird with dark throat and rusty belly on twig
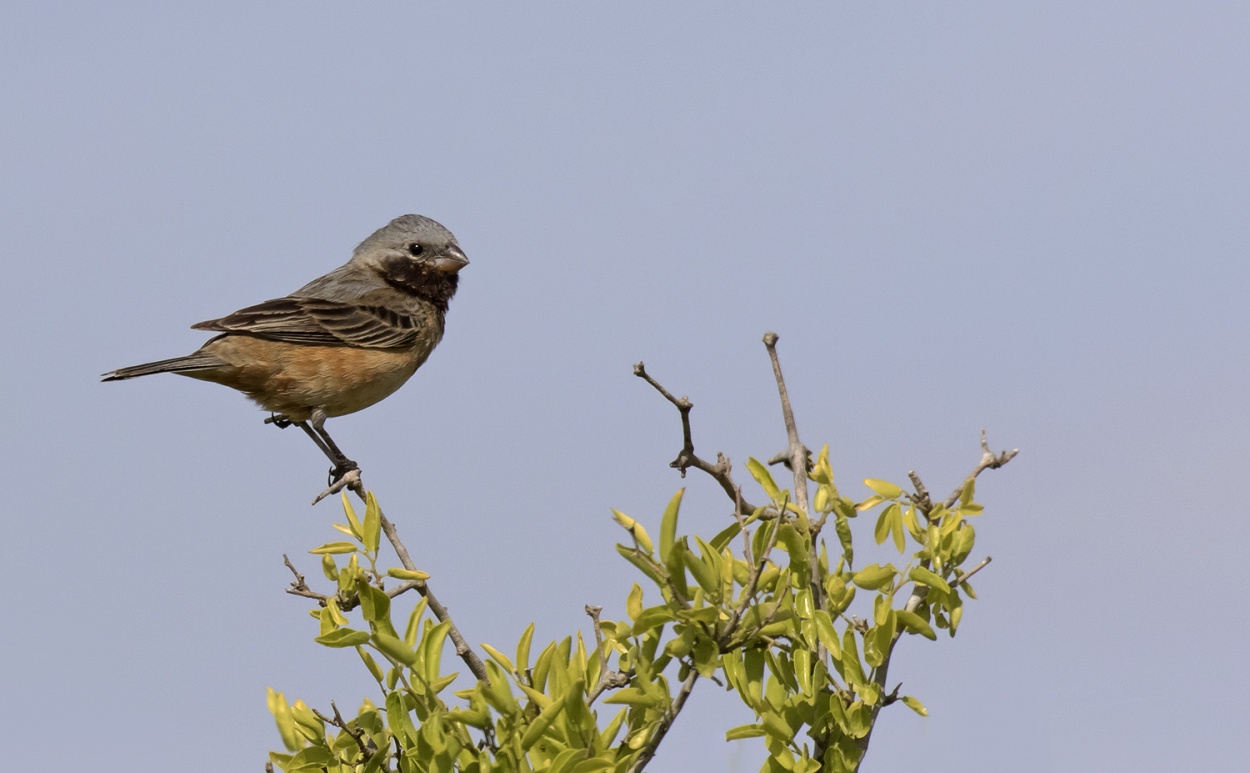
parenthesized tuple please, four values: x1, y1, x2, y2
(103, 215, 469, 480)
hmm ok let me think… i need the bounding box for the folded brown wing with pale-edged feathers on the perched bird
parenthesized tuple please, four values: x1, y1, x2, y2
(191, 296, 419, 349)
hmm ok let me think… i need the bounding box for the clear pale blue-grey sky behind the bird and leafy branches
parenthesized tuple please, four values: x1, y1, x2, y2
(0, 0, 1250, 773)
